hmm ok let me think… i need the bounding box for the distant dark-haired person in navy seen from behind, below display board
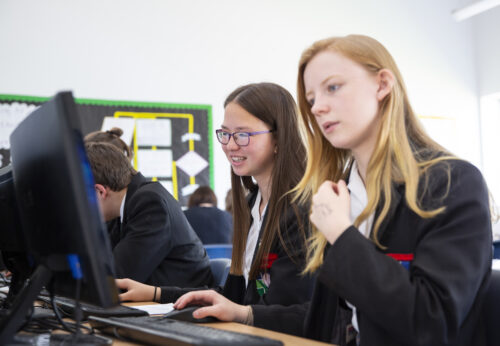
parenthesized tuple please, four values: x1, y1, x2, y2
(184, 186, 233, 244)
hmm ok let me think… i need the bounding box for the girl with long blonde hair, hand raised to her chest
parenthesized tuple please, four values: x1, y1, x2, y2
(175, 35, 491, 346)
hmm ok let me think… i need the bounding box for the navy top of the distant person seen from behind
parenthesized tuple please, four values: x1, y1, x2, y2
(184, 207, 233, 244)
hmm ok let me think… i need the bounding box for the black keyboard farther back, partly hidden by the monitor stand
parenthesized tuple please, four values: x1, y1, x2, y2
(38, 296, 148, 319)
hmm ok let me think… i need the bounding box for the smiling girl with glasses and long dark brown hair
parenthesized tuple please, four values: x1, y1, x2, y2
(117, 83, 313, 305)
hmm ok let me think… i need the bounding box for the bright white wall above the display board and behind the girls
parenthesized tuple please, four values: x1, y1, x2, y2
(0, 0, 480, 205)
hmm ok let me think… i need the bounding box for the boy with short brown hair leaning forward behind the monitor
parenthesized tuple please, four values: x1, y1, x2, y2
(85, 142, 213, 287)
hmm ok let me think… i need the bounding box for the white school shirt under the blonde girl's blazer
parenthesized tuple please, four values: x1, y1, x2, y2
(346, 161, 373, 333)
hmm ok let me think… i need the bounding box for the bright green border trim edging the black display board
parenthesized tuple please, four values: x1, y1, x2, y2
(0, 94, 215, 189)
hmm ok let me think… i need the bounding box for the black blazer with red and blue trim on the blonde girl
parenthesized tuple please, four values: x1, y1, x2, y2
(254, 160, 492, 346)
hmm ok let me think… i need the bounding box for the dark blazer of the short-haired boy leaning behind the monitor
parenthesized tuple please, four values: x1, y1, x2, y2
(110, 173, 213, 287)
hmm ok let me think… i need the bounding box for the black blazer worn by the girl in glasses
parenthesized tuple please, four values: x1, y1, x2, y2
(161, 192, 314, 305)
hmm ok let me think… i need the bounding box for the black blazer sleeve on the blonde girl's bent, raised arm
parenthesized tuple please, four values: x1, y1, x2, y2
(318, 162, 491, 345)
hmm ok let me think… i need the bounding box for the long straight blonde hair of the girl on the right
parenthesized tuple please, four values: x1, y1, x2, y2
(294, 35, 452, 272)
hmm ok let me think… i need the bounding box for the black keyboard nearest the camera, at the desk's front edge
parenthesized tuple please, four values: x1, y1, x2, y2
(89, 316, 283, 346)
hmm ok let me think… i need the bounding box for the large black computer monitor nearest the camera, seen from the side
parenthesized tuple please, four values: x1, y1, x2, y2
(0, 92, 118, 342)
